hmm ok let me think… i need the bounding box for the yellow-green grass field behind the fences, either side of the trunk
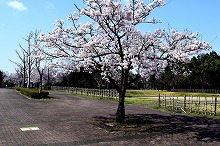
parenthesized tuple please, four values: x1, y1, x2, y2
(52, 90, 220, 118)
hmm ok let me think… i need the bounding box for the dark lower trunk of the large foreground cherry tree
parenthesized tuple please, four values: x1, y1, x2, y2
(116, 94, 125, 123)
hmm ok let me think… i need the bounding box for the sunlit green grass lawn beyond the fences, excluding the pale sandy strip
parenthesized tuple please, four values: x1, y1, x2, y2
(53, 90, 220, 118)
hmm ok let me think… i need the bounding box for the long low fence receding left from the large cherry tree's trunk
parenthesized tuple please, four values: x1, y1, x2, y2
(51, 86, 119, 99)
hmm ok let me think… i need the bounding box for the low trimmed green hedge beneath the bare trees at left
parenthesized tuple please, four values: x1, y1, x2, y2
(15, 87, 49, 99)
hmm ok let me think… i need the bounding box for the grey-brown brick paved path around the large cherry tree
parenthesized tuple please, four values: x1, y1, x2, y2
(0, 89, 220, 146)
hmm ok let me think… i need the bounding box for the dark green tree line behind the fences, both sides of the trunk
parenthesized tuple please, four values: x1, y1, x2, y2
(57, 51, 220, 90)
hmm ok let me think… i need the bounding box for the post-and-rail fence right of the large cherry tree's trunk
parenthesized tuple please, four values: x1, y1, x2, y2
(158, 95, 220, 116)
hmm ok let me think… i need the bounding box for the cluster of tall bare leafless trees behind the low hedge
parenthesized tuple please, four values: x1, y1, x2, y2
(7, 30, 62, 92)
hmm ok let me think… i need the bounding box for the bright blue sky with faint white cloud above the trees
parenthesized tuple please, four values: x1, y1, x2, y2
(0, 0, 220, 73)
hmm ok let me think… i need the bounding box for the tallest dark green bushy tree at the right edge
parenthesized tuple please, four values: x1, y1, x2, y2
(187, 51, 220, 89)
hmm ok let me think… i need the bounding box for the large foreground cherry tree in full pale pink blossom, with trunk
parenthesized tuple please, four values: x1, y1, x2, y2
(39, 0, 211, 122)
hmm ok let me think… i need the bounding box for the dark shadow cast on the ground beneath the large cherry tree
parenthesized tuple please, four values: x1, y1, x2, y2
(93, 114, 220, 142)
